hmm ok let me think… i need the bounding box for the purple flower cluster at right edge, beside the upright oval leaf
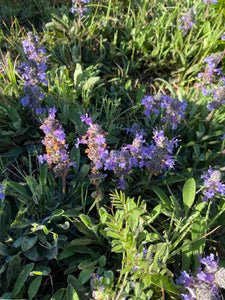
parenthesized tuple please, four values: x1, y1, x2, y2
(201, 167, 225, 200)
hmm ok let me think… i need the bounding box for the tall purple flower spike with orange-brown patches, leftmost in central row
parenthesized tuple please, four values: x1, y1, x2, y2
(38, 108, 75, 177)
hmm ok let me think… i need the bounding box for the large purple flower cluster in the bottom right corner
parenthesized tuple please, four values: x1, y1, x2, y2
(176, 253, 225, 300)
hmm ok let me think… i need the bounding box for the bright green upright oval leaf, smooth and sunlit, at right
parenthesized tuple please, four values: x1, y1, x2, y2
(183, 178, 196, 216)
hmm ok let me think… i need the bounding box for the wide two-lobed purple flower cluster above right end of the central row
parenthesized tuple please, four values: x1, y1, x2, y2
(141, 93, 187, 129)
